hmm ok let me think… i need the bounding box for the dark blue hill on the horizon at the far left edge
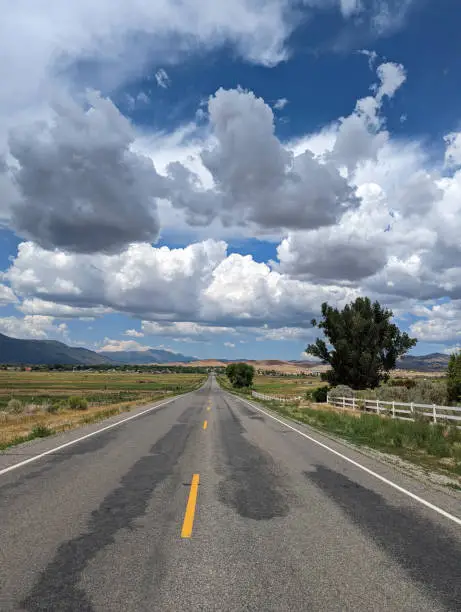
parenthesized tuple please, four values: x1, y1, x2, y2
(0, 334, 111, 365)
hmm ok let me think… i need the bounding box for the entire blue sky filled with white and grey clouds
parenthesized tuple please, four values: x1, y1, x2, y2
(0, 0, 461, 359)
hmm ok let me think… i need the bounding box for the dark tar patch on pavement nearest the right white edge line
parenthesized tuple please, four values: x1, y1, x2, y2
(304, 465, 461, 610)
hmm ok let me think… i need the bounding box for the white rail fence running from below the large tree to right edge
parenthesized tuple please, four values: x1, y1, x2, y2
(327, 396, 461, 426)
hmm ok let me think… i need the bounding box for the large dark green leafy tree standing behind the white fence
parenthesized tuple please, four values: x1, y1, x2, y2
(306, 297, 417, 389)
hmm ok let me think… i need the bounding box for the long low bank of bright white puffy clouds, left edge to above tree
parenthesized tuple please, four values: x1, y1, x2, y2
(6, 240, 356, 330)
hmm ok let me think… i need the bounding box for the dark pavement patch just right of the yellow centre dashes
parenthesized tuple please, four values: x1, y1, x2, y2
(217, 399, 290, 521)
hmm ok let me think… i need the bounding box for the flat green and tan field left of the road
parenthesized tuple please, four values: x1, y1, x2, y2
(0, 371, 206, 450)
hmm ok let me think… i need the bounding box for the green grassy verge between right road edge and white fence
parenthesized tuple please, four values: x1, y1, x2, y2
(218, 377, 461, 477)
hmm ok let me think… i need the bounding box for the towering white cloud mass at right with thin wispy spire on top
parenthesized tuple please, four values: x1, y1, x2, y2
(278, 58, 461, 302)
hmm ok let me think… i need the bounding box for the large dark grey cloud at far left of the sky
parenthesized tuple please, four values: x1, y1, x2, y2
(10, 94, 166, 253)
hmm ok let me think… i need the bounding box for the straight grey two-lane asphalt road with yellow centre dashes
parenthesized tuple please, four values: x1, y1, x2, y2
(0, 380, 461, 612)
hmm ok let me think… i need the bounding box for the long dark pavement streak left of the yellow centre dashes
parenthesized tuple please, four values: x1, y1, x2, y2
(21, 406, 201, 612)
